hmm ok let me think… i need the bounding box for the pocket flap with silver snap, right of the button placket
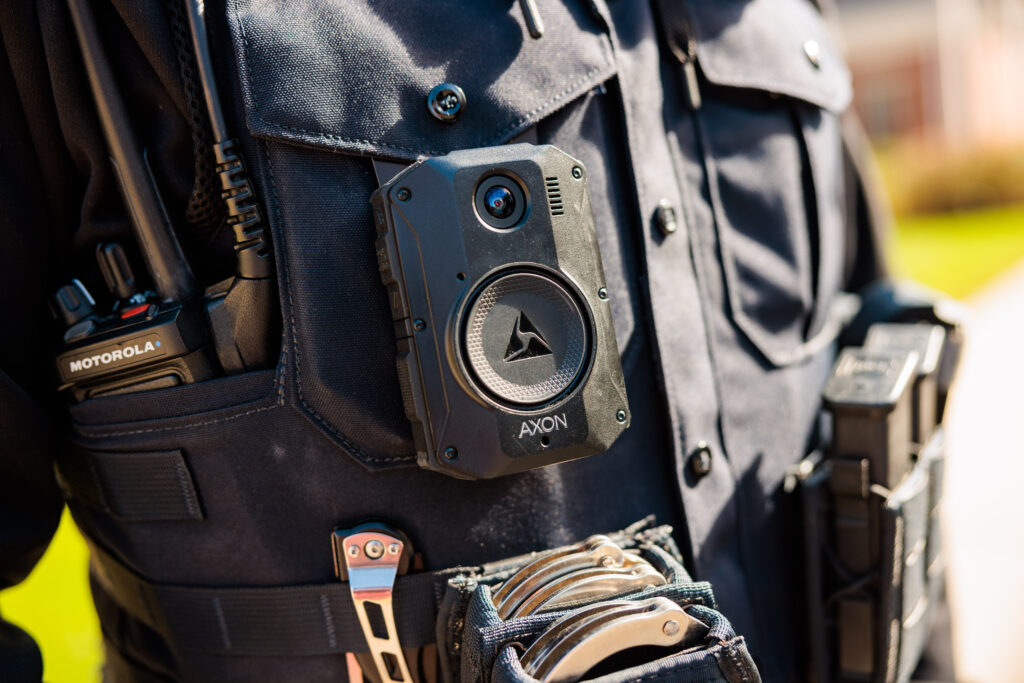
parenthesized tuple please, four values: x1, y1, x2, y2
(691, 0, 852, 113)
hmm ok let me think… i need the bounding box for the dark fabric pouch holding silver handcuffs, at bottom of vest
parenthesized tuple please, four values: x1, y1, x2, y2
(437, 520, 761, 683)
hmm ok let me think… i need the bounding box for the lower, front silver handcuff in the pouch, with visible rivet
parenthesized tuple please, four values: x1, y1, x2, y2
(522, 597, 708, 683)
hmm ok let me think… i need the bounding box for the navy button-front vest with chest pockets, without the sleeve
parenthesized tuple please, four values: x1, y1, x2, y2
(58, 0, 873, 681)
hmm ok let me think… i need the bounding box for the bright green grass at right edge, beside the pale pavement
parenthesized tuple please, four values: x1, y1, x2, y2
(890, 206, 1024, 299)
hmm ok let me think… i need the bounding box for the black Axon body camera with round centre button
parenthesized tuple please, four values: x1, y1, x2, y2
(372, 144, 630, 478)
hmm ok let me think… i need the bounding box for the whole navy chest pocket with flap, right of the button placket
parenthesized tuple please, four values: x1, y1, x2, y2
(694, 0, 850, 367)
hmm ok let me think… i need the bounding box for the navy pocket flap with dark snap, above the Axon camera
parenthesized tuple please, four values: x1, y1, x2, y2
(231, 0, 614, 160)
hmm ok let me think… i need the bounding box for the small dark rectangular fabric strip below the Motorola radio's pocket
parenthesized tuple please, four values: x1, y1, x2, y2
(57, 449, 203, 521)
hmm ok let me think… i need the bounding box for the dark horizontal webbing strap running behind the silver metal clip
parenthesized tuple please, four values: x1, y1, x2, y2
(92, 545, 456, 656)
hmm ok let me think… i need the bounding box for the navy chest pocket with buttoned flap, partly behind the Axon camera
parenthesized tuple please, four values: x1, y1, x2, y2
(228, 0, 618, 469)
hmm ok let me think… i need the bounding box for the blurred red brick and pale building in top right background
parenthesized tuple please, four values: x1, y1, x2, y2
(838, 0, 1024, 146)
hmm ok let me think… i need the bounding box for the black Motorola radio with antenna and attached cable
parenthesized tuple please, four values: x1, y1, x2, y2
(53, 0, 279, 400)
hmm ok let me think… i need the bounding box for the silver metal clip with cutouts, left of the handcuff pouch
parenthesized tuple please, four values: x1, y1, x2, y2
(331, 523, 414, 683)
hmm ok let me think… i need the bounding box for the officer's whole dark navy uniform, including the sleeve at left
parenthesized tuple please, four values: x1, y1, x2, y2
(0, 0, 879, 681)
